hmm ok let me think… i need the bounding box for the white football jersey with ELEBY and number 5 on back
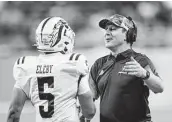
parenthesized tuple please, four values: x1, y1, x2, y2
(13, 53, 90, 122)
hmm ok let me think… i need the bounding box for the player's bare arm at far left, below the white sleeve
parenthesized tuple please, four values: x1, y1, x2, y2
(7, 87, 27, 122)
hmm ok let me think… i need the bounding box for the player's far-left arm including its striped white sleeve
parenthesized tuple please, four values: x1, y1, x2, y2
(7, 57, 29, 122)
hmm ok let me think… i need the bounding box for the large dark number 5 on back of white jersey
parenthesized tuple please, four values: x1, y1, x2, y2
(37, 76, 54, 118)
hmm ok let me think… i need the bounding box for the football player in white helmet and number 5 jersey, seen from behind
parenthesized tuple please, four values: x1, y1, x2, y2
(7, 17, 95, 122)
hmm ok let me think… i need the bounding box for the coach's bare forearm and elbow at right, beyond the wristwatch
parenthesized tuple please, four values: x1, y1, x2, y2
(144, 72, 164, 93)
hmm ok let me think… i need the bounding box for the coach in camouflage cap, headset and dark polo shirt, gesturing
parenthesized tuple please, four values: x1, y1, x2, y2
(89, 14, 163, 122)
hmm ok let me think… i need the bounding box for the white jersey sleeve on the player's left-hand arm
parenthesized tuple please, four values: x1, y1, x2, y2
(13, 58, 29, 97)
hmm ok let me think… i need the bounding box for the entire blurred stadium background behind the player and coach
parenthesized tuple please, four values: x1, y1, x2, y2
(0, 1, 172, 122)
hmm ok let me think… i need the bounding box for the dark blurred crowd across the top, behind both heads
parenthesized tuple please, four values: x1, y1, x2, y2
(0, 1, 172, 54)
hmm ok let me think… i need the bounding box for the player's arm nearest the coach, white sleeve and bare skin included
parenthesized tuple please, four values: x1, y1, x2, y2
(77, 55, 96, 119)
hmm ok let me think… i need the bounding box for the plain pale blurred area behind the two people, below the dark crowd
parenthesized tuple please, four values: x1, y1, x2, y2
(0, 47, 172, 122)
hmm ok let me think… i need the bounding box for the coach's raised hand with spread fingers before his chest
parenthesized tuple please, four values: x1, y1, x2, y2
(118, 57, 146, 78)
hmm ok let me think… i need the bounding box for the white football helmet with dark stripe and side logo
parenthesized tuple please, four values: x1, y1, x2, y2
(35, 17, 75, 53)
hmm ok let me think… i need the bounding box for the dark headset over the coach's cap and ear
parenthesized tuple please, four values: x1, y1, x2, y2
(126, 16, 137, 45)
